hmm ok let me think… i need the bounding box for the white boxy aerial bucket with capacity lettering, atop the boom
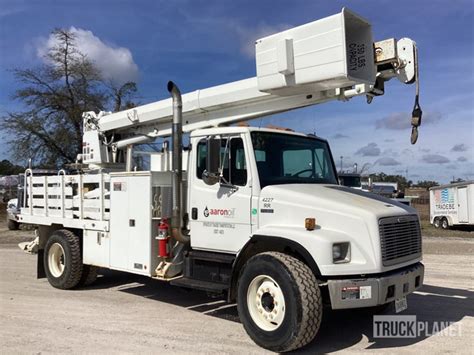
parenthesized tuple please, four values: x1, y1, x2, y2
(256, 8, 376, 95)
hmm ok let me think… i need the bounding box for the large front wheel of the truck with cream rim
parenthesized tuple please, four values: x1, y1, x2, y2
(237, 252, 322, 352)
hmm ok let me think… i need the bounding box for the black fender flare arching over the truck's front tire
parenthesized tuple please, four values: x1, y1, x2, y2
(227, 234, 321, 302)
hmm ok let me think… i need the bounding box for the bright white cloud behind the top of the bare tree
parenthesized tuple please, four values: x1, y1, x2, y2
(37, 27, 138, 85)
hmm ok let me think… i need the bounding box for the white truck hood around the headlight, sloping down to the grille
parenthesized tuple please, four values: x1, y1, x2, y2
(256, 184, 416, 276)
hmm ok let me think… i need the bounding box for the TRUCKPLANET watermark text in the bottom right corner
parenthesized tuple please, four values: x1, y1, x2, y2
(373, 315, 462, 338)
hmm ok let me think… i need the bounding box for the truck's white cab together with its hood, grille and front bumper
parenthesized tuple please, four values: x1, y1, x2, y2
(188, 127, 423, 308)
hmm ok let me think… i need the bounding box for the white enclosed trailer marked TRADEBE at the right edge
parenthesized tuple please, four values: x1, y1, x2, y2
(430, 180, 474, 229)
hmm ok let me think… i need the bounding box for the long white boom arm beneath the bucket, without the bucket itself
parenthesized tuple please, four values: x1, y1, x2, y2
(84, 77, 374, 137)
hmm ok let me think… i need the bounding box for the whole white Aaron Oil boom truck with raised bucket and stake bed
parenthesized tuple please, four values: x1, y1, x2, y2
(19, 9, 424, 351)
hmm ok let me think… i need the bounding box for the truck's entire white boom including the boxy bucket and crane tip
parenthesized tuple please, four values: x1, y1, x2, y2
(82, 9, 417, 164)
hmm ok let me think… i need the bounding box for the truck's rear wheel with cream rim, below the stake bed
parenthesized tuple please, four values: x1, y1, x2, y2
(43, 229, 83, 290)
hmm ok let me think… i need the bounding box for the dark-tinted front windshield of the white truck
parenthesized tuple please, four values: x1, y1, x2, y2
(252, 131, 337, 188)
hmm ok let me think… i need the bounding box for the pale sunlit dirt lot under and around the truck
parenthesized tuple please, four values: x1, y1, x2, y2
(0, 219, 474, 354)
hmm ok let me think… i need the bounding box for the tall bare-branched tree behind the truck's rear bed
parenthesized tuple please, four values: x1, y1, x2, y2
(0, 29, 137, 167)
